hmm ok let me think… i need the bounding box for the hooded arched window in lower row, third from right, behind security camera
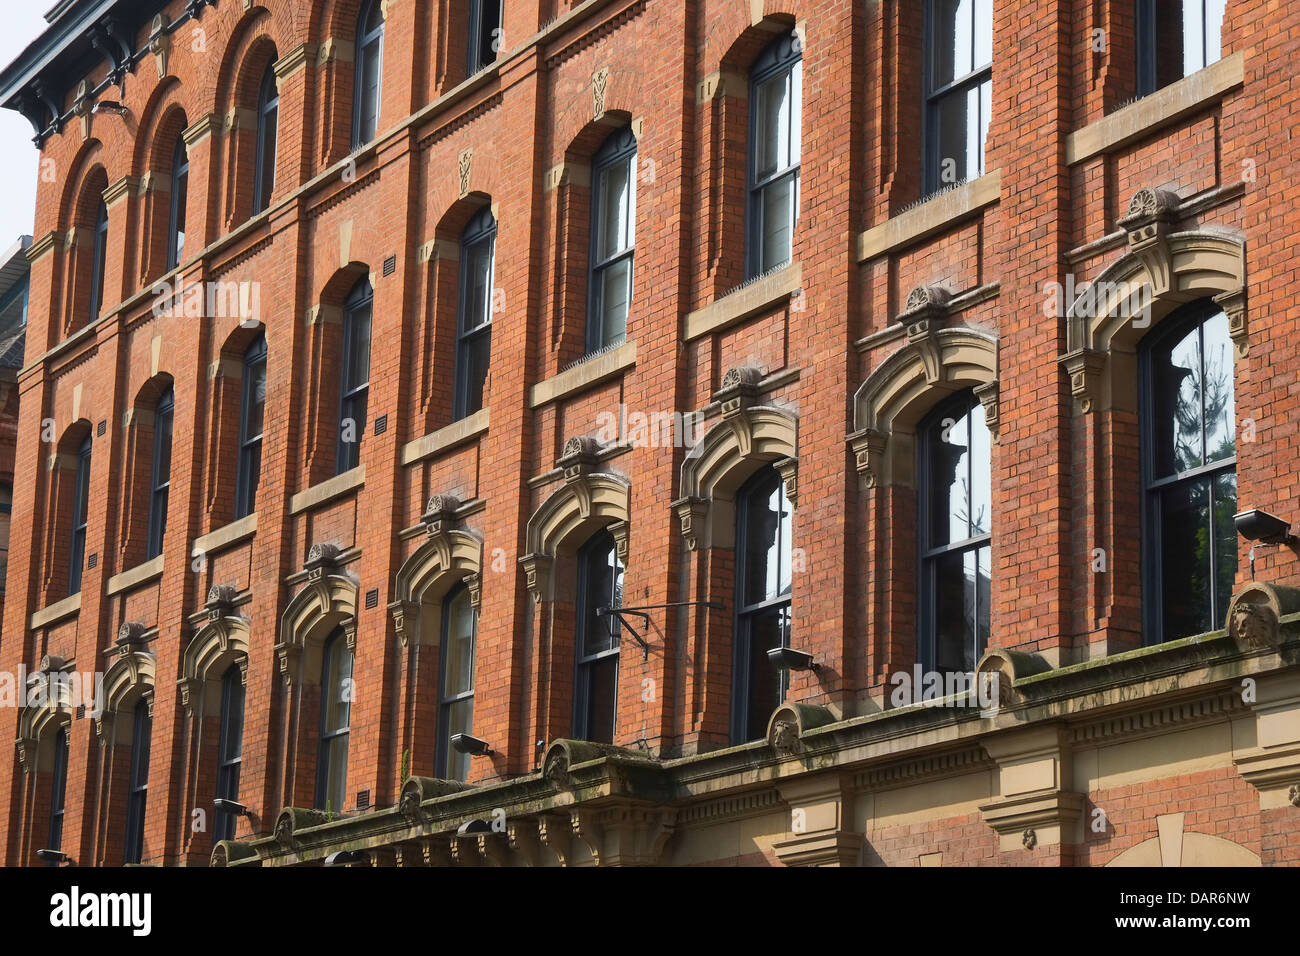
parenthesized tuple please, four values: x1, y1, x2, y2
(732, 466, 794, 744)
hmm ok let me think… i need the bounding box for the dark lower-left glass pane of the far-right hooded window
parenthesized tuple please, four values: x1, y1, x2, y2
(1158, 479, 1216, 641)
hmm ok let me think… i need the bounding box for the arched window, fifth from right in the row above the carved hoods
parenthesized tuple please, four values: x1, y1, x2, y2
(455, 209, 497, 419)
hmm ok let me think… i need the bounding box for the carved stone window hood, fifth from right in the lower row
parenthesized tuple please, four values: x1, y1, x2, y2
(389, 494, 482, 648)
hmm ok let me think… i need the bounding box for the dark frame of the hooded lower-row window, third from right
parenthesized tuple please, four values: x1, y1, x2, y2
(731, 464, 794, 744)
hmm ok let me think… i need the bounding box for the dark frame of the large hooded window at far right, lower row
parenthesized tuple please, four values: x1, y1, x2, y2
(1138, 299, 1236, 646)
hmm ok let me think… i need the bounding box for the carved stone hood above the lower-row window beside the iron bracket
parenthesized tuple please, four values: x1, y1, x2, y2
(519, 436, 632, 604)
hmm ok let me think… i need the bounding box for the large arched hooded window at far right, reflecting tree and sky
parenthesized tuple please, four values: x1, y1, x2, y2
(1140, 302, 1236, 644)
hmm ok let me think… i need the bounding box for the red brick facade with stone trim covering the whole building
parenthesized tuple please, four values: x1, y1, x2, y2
(0, 0, 1300, 865)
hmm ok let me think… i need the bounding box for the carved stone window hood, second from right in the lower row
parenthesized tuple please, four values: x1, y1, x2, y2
(849, 293, 1000, 488)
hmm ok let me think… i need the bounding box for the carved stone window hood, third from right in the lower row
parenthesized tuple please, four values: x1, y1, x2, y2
(672, 365, 798, 550)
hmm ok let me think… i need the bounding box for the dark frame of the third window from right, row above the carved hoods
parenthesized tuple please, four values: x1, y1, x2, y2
(745, 33, 803, 278)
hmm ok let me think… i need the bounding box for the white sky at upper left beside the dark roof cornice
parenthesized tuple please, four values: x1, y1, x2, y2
(0, 8, 53, 248)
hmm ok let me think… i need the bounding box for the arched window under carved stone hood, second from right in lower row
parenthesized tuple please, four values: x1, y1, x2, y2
(917, 392, 993, 674)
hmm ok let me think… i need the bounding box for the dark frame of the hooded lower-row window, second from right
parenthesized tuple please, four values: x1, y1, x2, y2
(917, 389, 993, 671)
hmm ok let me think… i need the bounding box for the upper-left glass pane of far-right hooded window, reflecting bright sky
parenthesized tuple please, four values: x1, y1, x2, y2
(1151, 319, 1201, 477)
